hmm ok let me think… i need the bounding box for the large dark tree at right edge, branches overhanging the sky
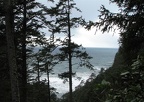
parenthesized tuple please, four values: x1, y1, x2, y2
(86, 0, 144, 102)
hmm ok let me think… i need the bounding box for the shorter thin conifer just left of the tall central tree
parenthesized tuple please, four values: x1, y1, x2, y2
(29, 34, 60, 102)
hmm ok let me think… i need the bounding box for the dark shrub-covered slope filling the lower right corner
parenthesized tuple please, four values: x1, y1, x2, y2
(62, 43, 144, 102)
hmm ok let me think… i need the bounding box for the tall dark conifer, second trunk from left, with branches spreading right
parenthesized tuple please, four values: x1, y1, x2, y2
(15, 0, 55, 102)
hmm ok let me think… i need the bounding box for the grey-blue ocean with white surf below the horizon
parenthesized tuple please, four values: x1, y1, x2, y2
(43, 48, 118, 97)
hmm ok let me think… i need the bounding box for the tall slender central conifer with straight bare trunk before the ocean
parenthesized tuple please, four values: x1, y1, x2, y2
(47, 0, 87, 102)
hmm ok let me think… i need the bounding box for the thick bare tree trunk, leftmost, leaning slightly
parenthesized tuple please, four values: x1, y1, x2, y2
(4, 0, 20, 102)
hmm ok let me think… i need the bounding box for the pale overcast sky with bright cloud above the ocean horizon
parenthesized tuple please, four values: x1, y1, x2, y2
(38, 0, 119, 48)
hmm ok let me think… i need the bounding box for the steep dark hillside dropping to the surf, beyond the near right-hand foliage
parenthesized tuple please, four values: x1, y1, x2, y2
(62, 49, 124, 102)
